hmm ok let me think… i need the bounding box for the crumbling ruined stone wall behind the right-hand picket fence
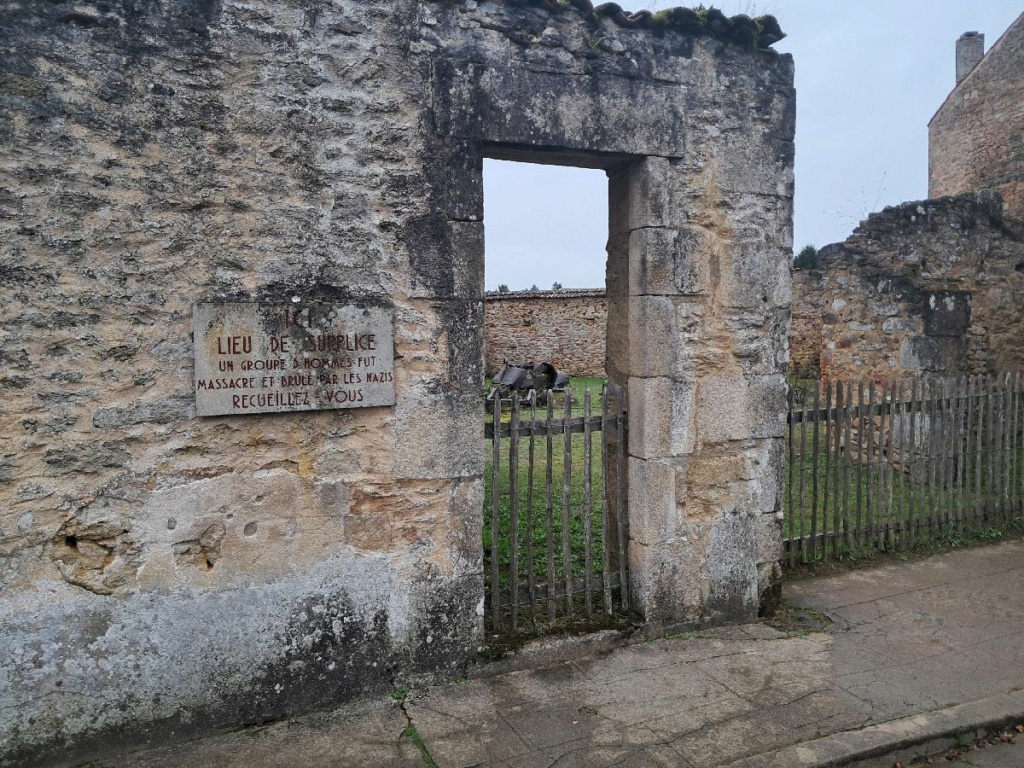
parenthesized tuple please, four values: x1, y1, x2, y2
(806, 193, 1024, 379)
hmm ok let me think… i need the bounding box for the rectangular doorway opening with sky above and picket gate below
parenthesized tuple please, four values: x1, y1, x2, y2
(483, 148, 629, 637)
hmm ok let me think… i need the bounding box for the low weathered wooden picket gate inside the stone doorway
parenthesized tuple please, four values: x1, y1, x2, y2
(483, 383, 630, 633)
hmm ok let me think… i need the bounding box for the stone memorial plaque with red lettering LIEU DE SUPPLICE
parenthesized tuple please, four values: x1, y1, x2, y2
(193, 302, 394, 416)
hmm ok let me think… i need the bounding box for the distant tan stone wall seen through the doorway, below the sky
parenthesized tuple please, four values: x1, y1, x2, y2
(483, 290, 608, 376)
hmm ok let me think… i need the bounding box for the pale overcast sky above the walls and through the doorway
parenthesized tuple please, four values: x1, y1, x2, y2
(483, 0, 1024, 291)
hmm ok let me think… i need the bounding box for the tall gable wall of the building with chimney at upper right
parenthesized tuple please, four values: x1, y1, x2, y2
(928, 14, 1024, 219)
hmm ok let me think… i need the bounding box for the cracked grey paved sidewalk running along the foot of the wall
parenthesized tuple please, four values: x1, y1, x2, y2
(70, 542, 1024, 768)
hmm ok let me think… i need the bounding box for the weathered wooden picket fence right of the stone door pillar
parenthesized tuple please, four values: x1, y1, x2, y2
(783, 374, 1024, 565)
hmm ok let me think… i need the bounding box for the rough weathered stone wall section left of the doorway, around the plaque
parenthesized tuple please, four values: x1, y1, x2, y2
(0, 0, 483, 765)
